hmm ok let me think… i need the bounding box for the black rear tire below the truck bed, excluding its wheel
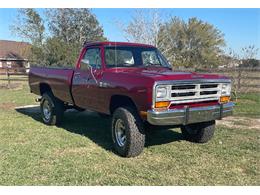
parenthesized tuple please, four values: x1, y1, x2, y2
(40, 92, 65, 125)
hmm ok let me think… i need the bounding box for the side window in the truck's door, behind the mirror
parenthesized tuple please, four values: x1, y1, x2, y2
(80, 48, 101, 70)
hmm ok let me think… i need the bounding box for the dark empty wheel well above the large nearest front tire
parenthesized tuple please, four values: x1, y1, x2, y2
(109, 95, 137, 114)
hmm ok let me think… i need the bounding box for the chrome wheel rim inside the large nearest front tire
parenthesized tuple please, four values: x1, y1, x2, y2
(115, 119, 126, 147)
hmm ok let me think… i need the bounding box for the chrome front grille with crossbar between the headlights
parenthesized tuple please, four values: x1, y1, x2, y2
(171, 83, 221, 104)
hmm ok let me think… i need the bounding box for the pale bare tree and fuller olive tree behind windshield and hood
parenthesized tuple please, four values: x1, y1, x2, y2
(120, 10, 225, 68)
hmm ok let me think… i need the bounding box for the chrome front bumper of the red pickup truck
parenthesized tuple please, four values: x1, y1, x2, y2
(147, 102, 234, 125)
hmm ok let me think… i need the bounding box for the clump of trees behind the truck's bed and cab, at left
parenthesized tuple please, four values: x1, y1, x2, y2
(11, 9, 106, 66)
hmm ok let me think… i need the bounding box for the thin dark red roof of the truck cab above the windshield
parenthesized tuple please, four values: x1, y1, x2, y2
(84, 41, 154, 47)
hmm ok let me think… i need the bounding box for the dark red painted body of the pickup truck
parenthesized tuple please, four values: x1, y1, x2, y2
(29, 42, 227, 114)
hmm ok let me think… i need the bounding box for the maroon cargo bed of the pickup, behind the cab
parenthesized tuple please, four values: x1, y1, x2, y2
(29, 67, 74, 104)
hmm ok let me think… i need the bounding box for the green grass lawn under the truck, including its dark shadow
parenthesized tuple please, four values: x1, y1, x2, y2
(0, 85, 260, 185)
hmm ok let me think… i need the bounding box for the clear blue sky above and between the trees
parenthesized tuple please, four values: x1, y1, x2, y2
(0, 8, 260, 59)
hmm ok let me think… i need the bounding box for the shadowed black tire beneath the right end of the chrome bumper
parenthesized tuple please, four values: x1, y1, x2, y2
(181, 120, 215, 143)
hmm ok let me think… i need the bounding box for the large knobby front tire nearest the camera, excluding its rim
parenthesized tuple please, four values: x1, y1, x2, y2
(112, 107, 145, 157)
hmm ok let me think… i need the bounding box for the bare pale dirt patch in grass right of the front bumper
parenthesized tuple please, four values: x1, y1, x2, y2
(217, 116, 260, 130)
